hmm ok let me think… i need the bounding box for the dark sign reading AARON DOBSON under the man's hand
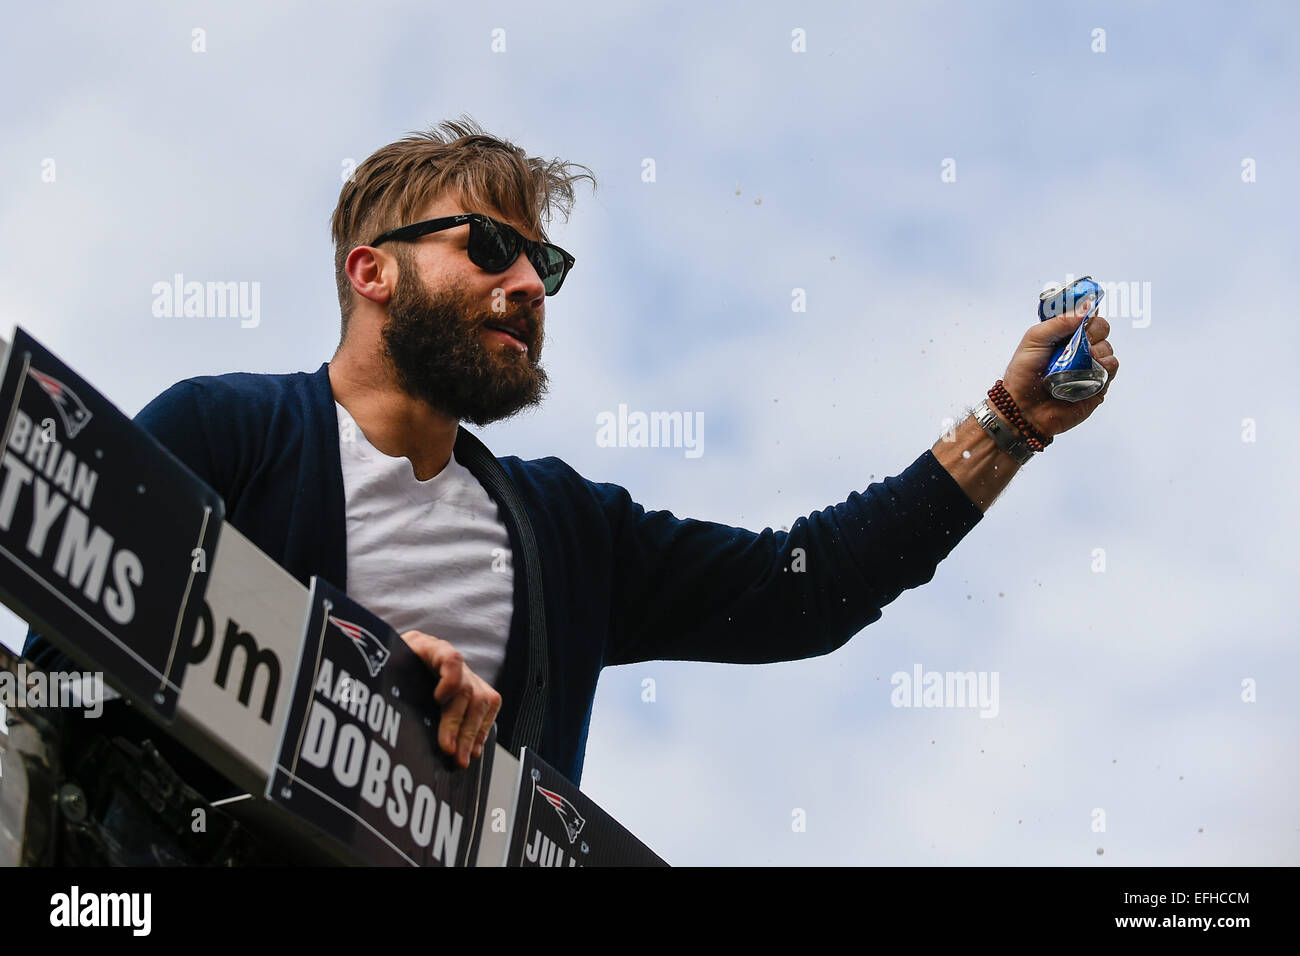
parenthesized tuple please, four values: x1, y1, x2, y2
(267, 578, 497, 866)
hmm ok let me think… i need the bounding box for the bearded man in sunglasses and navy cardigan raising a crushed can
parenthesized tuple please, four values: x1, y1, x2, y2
(20, 113, 1119, 858)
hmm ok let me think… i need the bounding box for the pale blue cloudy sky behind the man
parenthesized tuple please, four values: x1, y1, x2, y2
(0, 0, 1300, 866)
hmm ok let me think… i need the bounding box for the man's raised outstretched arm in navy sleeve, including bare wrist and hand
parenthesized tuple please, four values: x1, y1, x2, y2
(598, 310, 1119, 663)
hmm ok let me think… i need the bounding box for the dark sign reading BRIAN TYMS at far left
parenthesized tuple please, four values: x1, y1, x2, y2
(0, 328, 225, 721)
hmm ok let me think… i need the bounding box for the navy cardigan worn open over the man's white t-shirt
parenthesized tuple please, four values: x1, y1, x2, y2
(26, 363, 983, 784)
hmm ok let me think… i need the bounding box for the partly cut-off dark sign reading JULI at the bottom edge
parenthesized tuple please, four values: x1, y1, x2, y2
(506, 748, 668, 866)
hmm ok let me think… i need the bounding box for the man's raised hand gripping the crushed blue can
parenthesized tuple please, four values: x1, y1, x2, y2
(1002, 306, 1119, 436)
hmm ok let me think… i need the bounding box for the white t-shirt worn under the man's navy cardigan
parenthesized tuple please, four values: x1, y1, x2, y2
(334, 402, 515, 687)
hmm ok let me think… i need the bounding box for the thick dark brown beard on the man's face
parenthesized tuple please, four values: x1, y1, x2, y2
(382, 256, 547, 425)
